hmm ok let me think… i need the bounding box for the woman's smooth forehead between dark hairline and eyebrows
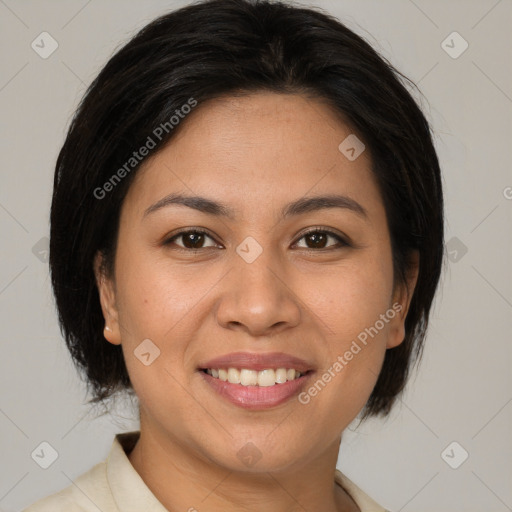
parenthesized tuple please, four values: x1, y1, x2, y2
(125, 93, 380, 216)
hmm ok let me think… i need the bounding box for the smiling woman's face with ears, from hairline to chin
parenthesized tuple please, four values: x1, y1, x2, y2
(99, 93, 416, 471)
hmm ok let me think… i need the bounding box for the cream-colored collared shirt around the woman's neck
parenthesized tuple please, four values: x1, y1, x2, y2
(23, 431, 388, 512)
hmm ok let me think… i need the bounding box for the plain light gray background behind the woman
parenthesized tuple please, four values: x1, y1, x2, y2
(0, 0, 512, 512)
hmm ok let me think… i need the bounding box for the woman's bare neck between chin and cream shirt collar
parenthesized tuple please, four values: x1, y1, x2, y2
(128, 418, 360, 512)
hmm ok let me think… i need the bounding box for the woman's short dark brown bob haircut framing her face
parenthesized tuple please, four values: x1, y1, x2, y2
(49, 0, 444, 419)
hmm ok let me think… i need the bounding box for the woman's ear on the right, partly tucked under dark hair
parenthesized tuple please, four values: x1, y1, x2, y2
(386, 250, 420, 348)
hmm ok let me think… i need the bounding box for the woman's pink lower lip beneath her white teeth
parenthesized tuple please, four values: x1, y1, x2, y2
(199, 370, 313, 409)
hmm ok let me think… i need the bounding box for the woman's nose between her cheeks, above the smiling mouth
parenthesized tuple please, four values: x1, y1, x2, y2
(216, 250, 301, 336)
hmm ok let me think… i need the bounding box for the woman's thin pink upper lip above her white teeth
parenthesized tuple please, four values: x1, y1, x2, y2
(199, 352, 313, 372)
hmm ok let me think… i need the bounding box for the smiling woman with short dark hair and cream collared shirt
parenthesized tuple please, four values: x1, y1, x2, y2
(23, 0, 443, 512)
